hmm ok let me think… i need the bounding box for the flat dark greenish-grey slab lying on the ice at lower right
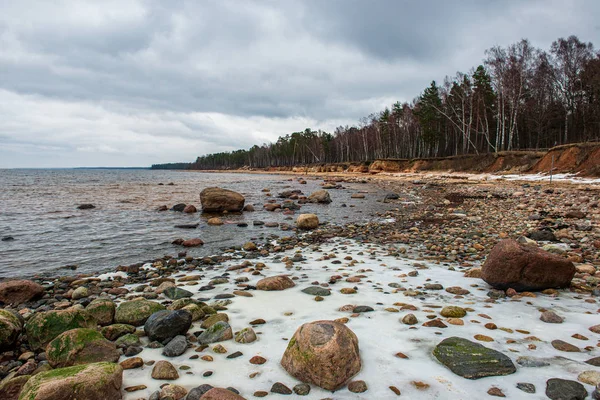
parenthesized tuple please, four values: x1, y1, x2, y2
(433, 337, 517, 379)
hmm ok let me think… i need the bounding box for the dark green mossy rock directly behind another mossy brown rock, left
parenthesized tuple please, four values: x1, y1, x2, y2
(25, 310, 97, 350)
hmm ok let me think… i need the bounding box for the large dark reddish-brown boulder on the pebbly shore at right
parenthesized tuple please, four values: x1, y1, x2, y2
(481, 239, 575, 291)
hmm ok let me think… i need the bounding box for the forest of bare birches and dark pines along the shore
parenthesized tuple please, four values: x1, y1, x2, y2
(152, 36, 600, 169)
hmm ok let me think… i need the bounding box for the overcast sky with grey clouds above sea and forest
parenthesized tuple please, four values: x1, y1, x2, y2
(0, 0, 600, 168)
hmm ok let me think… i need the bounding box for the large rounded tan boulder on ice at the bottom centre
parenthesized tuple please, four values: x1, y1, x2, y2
(281, 321, 361, 390)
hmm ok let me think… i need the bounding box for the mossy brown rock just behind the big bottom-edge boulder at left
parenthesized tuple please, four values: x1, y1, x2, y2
(46, 328, 120, 368)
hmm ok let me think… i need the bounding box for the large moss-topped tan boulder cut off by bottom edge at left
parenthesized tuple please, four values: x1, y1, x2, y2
(19, 362, 123, 400)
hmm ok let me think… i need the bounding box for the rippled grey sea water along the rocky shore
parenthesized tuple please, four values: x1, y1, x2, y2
(0, 170, 384, 278)
